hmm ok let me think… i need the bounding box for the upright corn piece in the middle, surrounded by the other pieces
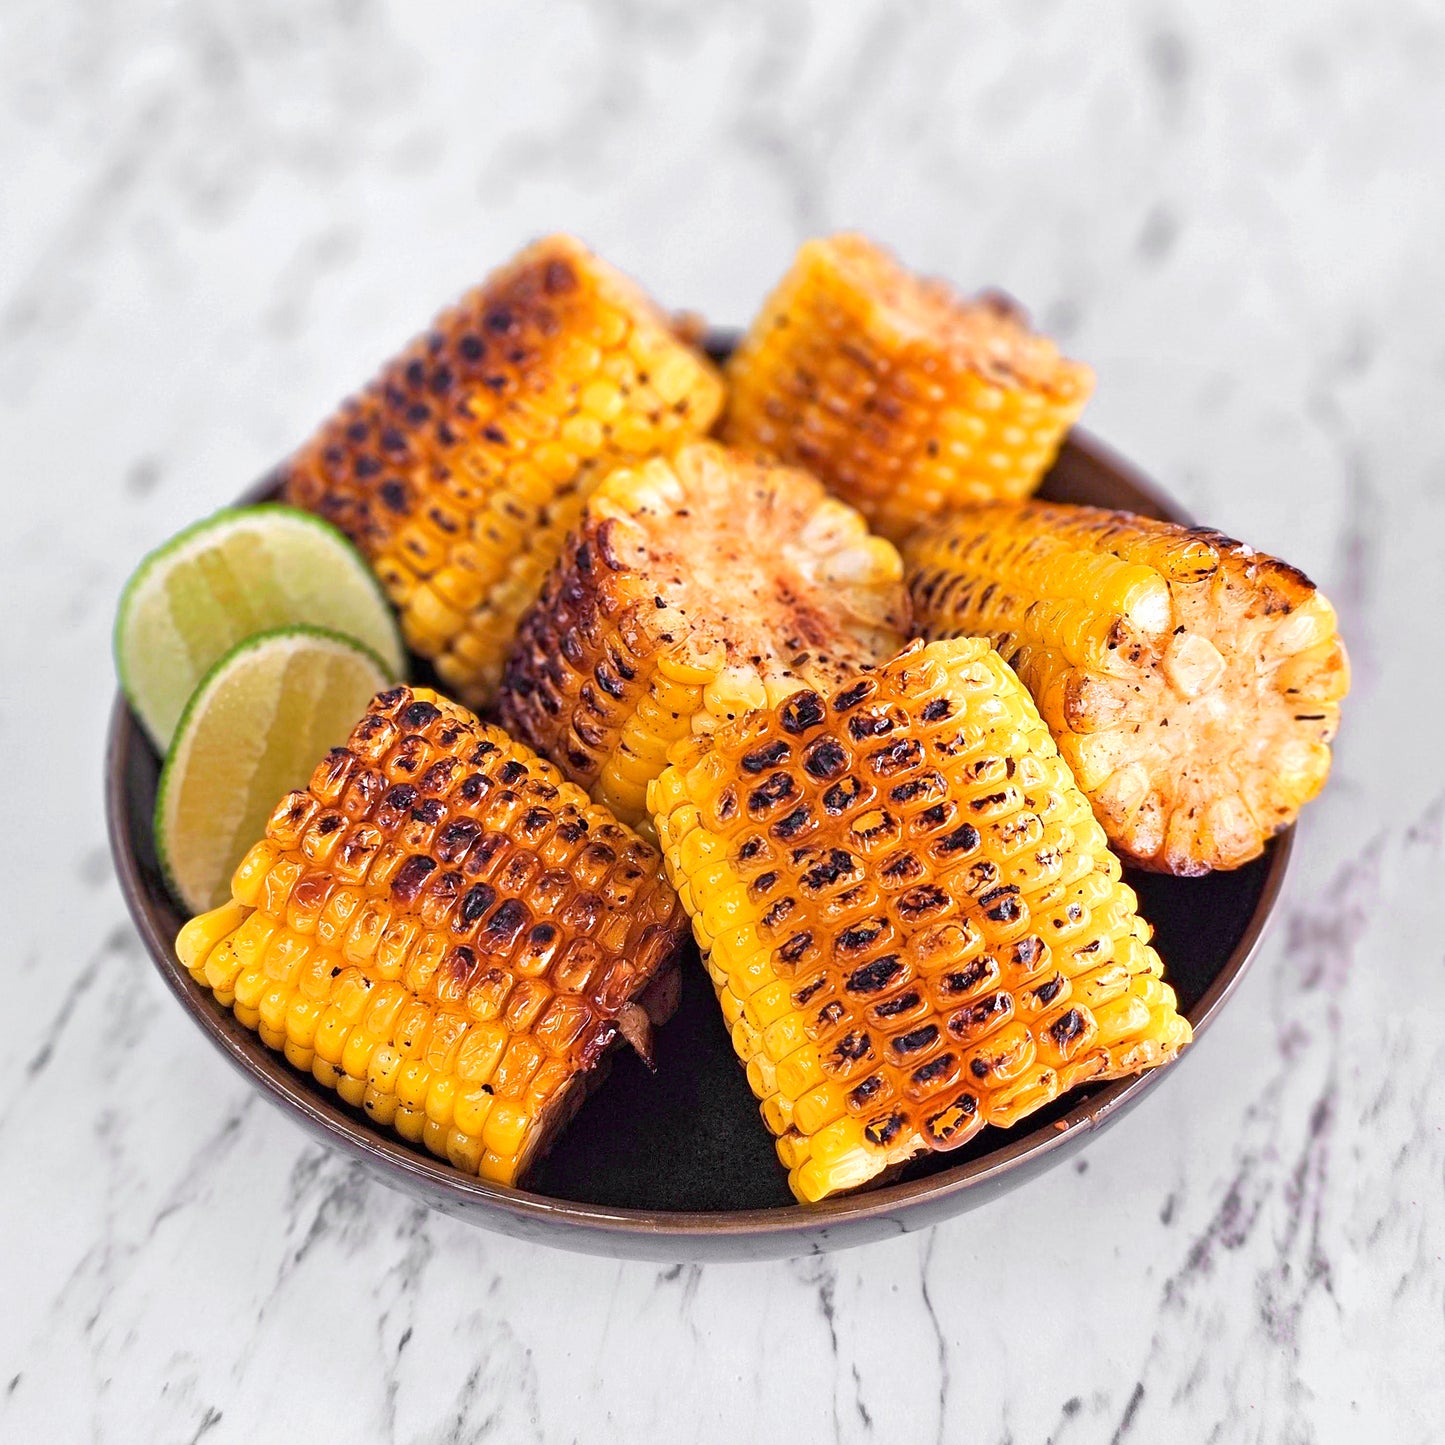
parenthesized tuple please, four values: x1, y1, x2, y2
(501, 442, 907, 832)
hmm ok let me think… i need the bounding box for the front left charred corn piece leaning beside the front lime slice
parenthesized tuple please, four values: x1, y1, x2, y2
(176, 688, 686, 1185)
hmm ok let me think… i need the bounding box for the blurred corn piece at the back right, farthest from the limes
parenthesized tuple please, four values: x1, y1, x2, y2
(723, 236, 1094, 542)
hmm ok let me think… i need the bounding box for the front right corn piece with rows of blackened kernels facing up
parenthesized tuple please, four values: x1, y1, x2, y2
(652, 639, 1189, 1202)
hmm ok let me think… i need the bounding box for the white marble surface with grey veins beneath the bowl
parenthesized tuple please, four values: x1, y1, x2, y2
(0, 0, 1445, 1445)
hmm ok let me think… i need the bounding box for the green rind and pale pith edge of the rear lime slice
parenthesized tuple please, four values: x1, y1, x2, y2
(111, 501, 406, 751)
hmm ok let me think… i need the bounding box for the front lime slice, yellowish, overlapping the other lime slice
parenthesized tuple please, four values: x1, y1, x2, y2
(156, 627, 396, 913)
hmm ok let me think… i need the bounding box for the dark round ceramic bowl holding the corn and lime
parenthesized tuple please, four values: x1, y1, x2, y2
(105, 335, 1292, 1260)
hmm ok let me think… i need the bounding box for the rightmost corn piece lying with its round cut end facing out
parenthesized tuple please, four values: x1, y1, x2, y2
(905, 501, 1350, 874)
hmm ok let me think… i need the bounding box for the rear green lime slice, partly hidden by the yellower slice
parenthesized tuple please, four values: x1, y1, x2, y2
(116, 504, 405, 751)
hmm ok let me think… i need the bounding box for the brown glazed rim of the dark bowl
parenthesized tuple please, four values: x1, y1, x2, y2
(105, 428, 1295, 1247)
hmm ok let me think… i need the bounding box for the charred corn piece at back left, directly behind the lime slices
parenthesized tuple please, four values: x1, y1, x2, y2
(282, 236, 723, 705)
